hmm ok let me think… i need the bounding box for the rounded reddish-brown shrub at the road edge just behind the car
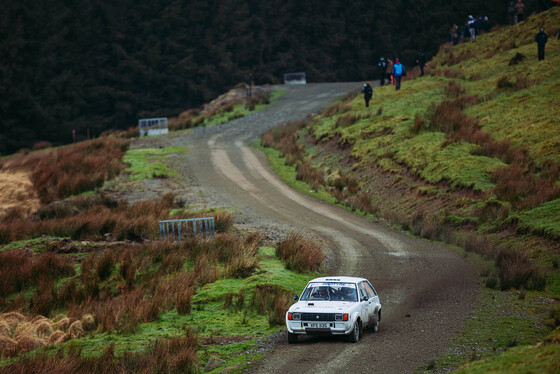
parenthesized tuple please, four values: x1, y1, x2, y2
(276, 234, 325, 273)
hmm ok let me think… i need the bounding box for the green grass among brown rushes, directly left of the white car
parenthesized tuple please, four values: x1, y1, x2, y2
(0, 247, 320, 367)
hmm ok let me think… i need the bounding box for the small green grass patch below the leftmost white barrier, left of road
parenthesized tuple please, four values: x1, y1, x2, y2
(123, 147, 188, 180)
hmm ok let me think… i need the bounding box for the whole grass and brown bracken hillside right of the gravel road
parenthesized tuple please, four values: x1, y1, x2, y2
(262, 8, 560, 373)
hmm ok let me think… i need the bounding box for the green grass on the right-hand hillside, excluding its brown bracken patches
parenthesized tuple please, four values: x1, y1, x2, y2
(266, 8, 560, 372)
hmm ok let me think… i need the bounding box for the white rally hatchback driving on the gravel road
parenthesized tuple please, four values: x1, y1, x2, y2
(286, 277, 381, 344)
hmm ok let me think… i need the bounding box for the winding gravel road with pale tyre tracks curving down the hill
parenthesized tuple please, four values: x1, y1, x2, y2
(134, 83, 478, 373)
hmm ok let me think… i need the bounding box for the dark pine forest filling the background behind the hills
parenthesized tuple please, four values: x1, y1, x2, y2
(0, 0, 552, 154)
